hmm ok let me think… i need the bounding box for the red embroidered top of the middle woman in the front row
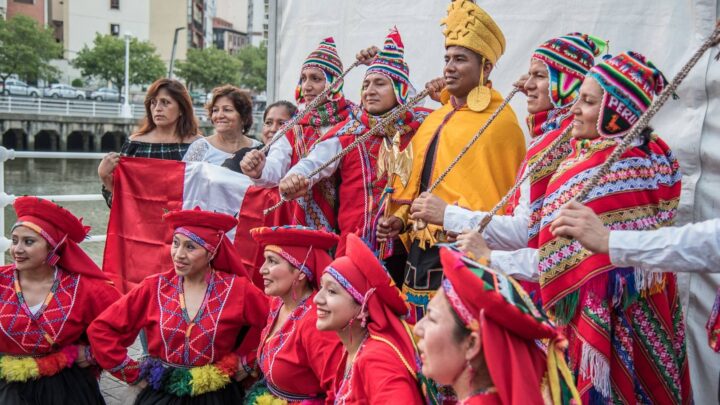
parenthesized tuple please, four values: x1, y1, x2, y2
(258, 294, 343, 404)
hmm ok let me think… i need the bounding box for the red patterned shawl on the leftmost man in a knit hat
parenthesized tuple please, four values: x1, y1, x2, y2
(287, 97, 354, 231)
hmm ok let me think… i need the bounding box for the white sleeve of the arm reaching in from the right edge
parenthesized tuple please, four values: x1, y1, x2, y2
(609, 219, 720, 273)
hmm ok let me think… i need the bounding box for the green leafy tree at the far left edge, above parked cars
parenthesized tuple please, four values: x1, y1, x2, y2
(0, 15, 62, 89)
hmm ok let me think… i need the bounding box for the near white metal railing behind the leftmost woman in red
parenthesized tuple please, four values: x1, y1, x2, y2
(0, 146, 105, 264)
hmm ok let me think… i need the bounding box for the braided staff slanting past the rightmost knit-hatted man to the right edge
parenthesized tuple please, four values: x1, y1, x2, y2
(575, 21, 720, 202)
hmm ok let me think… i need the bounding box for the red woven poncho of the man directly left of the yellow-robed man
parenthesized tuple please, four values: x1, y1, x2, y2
(324, 107, 430, 254)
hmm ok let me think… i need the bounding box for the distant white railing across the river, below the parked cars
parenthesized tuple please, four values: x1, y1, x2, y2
(0, 96, 207, 121)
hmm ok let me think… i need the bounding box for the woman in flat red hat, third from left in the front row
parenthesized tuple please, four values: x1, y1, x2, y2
(246, 226, 343, 404)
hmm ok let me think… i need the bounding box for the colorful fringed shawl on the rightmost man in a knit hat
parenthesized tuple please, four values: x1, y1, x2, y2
(539, 136, 691, 403)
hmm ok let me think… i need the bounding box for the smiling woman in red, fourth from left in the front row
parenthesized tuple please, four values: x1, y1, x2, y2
(315, 234, 425, 404)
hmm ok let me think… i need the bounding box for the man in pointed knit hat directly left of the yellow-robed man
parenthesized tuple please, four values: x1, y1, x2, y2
(280, 28, 430, 262)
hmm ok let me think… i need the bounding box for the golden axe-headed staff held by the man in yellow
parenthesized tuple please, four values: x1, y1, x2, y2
(376, 132, 413, 260)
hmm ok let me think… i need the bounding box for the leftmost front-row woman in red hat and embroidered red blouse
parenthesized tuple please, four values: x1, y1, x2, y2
(0, 197, 120, 405)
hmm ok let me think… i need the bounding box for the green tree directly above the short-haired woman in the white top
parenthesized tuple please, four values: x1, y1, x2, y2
(175, 48, 240, 90)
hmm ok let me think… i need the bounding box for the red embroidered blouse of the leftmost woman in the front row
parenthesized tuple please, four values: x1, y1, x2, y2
(0, 265, 120, 357)
